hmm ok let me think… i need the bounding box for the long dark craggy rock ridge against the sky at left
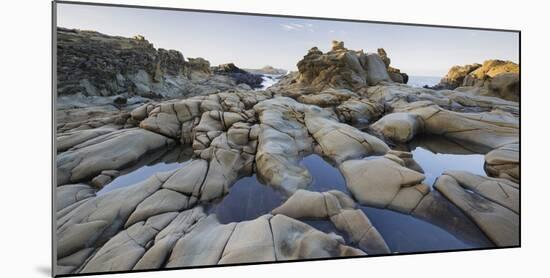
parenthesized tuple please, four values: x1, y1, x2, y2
(57, 27, 243, 106)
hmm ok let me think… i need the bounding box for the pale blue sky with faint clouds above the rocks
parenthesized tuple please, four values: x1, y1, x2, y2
(57, 4, 519, 76)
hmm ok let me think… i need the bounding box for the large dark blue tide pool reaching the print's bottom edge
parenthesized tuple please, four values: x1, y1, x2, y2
(361, 206, 476, 253)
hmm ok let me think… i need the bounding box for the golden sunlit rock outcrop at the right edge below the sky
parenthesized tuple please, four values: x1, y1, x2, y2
(431, 60, 520, 101)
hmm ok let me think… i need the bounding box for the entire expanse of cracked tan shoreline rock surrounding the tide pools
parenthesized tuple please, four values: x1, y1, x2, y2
(55, 29, 520, 274)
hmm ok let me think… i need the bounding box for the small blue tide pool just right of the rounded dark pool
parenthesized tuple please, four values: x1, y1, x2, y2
(301, 154, 349, 195)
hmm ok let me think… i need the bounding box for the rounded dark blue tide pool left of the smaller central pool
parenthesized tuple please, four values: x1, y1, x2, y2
(207, 175, 283, 224)
